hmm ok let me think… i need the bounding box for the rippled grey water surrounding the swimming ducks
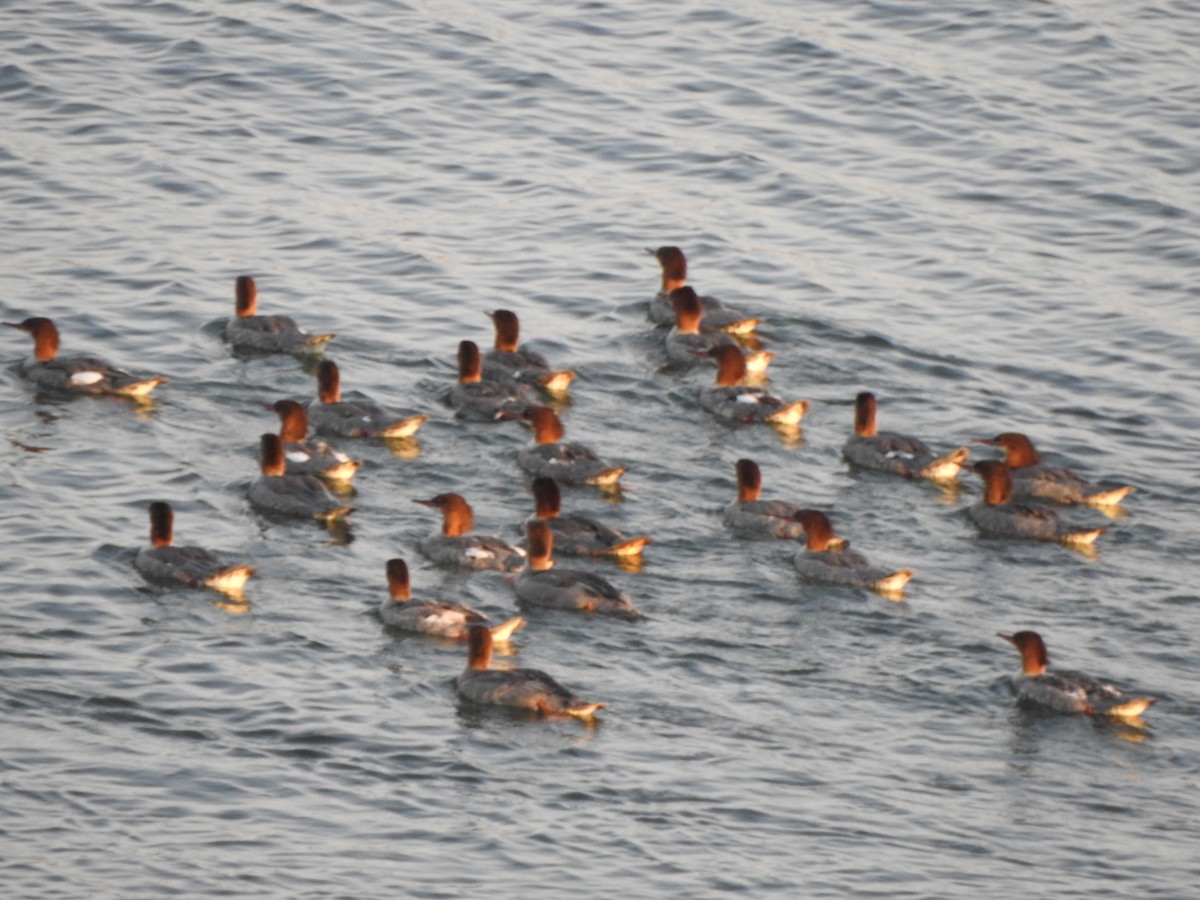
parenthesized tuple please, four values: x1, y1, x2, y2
(0, 0, 1200, 899)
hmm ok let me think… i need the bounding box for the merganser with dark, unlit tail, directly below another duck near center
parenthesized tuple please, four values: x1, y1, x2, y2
(514, 521, 642, 619)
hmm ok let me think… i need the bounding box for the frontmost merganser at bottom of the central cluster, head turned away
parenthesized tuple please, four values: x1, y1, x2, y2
(456, 625, 604, 721)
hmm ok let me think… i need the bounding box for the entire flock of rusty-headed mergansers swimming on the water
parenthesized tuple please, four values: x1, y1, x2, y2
(5, 246, 1153, 721)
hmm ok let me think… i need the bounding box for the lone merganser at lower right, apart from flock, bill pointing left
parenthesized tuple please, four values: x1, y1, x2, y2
(997, 631, 1154, 719)
